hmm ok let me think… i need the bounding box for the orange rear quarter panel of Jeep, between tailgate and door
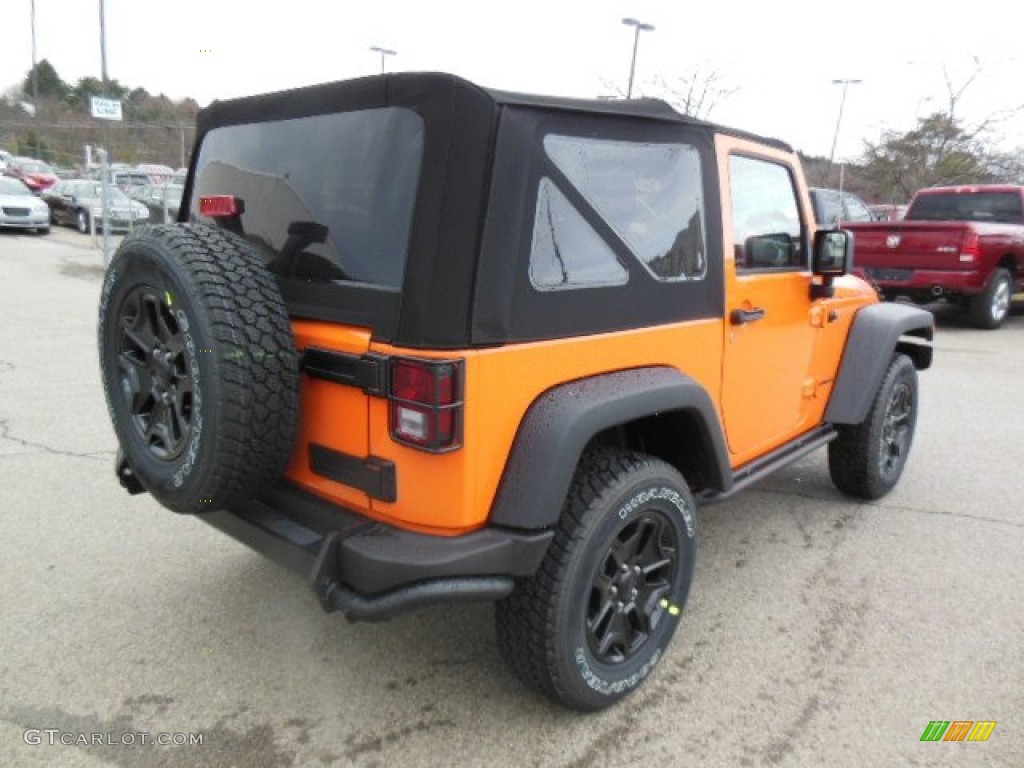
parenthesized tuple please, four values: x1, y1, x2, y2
(370, 319, 722, 535)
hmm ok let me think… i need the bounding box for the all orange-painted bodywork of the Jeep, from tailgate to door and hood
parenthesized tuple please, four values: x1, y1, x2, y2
(288, 135, 877, 536)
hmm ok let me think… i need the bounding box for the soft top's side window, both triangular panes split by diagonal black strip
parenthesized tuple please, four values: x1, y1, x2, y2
(530, 134, 708, 290)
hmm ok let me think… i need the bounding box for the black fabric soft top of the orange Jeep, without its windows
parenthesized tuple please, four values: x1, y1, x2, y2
(181, 73, 792, 348)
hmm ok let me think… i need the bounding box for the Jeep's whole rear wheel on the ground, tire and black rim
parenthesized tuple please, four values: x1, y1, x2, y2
(497, 449, 696, 710)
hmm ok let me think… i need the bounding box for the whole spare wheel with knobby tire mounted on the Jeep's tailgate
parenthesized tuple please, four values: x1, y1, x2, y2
(98, 224, 298, 514)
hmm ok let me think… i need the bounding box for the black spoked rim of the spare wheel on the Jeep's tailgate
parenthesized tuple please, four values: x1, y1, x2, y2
(118, 286, 194, 461)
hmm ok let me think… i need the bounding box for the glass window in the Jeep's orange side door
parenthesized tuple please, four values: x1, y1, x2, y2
(729, 155, 806, 270)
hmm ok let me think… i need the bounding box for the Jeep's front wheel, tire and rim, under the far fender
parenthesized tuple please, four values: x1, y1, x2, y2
(828, 354, 918, 500)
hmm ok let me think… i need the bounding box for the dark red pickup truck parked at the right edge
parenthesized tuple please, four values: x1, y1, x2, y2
(843, 184, 1024, 329)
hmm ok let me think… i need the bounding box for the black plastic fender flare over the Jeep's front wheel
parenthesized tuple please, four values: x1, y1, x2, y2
(825, 303, 935, 424)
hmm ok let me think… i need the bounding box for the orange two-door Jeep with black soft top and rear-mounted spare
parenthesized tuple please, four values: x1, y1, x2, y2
(98, 74, 933, 710)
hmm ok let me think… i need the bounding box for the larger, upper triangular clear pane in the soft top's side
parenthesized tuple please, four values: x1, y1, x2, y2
(544, 134, 708, 282)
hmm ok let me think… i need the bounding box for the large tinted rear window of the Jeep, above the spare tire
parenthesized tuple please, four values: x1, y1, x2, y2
(191, 108, 424, 290)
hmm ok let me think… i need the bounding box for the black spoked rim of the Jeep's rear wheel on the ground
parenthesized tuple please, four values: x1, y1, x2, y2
(587, 509, 679, 665)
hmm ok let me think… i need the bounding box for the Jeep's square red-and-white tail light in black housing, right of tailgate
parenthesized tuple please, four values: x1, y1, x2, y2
(388, 357, 463, 453)
